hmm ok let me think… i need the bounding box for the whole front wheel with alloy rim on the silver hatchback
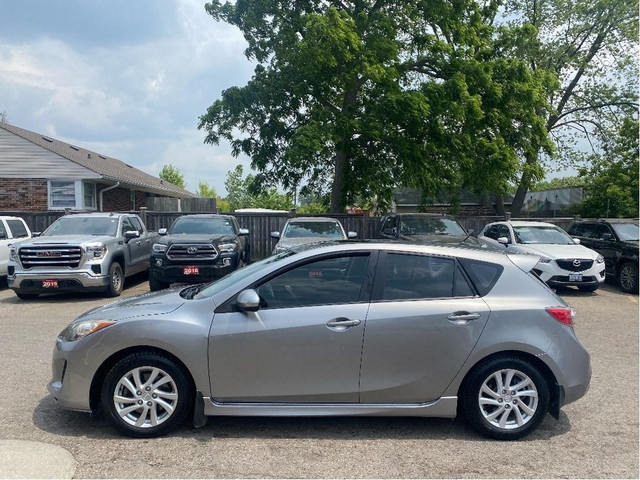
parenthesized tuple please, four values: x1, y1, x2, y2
(101, 352, 193, 438)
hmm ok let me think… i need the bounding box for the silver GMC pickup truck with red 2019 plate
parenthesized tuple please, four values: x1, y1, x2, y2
(7, 213, 158, 299)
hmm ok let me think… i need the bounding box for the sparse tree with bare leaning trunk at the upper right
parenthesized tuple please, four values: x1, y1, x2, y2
(501, 0, 638, 215)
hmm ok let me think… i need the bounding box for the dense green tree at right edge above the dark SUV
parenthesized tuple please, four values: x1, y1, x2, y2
(580, 118, 640, 218)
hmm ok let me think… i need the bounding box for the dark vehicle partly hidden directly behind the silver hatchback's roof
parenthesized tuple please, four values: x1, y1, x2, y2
(380, 213, 480, 245)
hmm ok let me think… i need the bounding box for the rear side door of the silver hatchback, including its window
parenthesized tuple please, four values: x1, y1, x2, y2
(360, 252, 489, 404)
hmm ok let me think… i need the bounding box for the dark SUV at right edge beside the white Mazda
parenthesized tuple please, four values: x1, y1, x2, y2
(568, 219, 638, 293)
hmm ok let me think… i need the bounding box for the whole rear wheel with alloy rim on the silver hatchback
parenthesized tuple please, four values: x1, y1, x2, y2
(462, 356, 550, 440)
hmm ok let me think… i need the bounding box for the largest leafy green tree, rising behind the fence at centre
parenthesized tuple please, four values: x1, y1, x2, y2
(199, 0, 556, 212)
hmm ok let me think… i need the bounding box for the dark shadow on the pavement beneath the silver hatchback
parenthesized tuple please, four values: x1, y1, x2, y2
(33, 395, 571, 442)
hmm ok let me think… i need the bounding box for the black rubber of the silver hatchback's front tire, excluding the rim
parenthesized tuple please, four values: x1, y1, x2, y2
(100, 352, 193, 438)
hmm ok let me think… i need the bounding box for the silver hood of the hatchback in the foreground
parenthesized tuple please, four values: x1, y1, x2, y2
(77, 286, 186, 320)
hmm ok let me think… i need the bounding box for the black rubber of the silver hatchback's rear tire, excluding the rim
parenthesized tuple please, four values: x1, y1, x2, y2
(462, 357, 550, 440)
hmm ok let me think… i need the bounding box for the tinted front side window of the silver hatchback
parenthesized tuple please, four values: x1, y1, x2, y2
(256, 254, 369, 308)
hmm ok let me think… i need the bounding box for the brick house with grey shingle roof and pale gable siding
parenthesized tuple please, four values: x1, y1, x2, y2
(0, 122, 196, 212)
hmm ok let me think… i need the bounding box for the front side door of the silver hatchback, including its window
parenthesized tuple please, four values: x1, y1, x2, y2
(209, 252, 372, 403)
